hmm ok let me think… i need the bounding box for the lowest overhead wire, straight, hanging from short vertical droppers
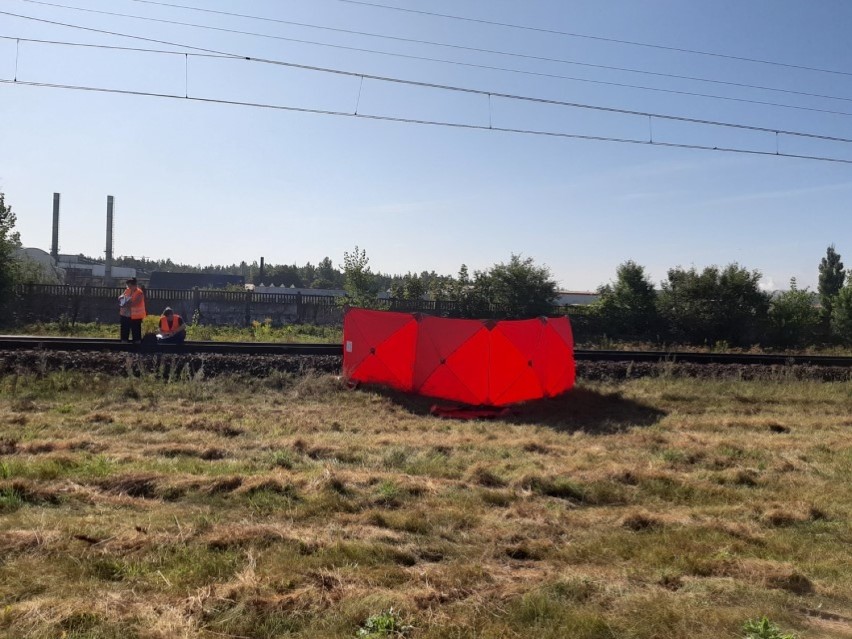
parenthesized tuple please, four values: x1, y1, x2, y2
(6, 79, 852, 164)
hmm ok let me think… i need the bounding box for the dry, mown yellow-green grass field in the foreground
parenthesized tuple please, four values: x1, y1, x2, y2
(0, 372, 852, 639)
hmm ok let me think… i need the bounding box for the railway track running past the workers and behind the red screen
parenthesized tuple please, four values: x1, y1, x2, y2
(0, 335, 852, 367)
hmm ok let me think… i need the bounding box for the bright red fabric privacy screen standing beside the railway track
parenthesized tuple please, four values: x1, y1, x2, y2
(343, 308, 574, 406)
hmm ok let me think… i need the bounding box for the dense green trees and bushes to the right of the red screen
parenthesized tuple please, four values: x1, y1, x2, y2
(590, 246, 852, 347)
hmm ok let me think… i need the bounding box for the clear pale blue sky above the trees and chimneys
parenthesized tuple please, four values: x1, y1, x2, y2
(0, 0, 852, 290)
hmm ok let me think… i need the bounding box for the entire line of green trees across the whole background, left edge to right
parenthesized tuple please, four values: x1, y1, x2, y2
(0, 193, 852, 346)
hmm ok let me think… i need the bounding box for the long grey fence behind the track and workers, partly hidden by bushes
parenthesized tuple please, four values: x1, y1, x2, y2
(12, 284, 588, 326)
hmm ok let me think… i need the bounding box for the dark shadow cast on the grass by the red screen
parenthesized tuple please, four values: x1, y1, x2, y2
(370, 387, 666, 435)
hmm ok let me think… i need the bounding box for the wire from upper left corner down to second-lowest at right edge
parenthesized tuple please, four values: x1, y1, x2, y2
(5, 11, 852, 148)
